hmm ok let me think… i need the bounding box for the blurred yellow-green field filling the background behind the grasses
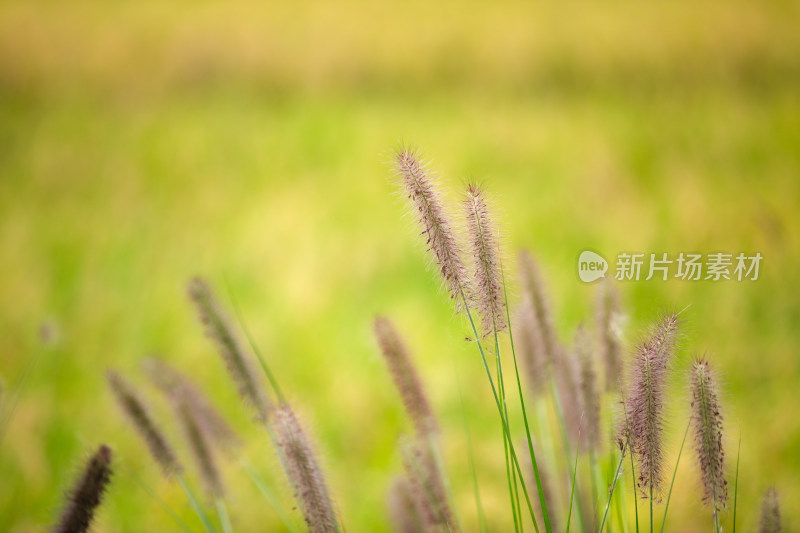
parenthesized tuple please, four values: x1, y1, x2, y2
(0, 0, 800, 533)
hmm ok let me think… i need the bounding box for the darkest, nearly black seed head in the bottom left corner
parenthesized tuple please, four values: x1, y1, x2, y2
(53, 444, 112, 533)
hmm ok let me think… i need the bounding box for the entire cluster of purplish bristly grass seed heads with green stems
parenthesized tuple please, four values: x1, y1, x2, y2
(29, 149, 780, 533)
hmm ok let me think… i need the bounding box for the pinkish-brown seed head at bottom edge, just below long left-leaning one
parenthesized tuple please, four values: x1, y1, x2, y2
(272, 404, 339, 533)
